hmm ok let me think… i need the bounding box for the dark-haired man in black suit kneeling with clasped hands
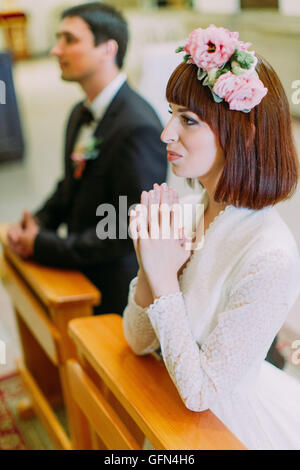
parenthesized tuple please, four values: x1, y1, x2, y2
(9, 2, 167, 314)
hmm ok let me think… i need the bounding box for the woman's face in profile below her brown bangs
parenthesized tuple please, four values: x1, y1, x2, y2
(161, 103, 225, 187)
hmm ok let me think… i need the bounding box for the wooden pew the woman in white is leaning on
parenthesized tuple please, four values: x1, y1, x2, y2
(67, 314, 245, 450)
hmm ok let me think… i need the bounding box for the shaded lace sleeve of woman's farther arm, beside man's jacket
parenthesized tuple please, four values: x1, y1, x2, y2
(123, 277, 159, 356)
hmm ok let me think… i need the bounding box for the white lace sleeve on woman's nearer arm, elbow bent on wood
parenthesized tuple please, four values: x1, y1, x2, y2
(148, 251, 295, 411)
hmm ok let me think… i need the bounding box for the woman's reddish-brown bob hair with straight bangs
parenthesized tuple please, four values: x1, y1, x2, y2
(166, 55, 299, 209)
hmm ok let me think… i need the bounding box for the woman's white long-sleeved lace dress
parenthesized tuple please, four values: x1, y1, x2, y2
(123, 196, 300, 450)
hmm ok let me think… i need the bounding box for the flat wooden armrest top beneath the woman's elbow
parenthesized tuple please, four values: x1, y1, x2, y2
(69, 315, 245, 450)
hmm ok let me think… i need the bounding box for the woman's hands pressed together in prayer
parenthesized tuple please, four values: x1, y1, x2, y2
(130, 183, 191, 297)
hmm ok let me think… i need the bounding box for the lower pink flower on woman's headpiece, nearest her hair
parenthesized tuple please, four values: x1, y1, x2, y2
(213, 72, 268, 111)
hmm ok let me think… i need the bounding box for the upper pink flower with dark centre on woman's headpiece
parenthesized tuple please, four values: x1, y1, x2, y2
(184, 24, 239, 71)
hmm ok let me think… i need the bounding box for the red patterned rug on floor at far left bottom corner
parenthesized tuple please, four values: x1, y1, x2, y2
(0, 373, 28, 450)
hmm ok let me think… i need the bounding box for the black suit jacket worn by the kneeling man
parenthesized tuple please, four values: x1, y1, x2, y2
(33, 83, 167, 314)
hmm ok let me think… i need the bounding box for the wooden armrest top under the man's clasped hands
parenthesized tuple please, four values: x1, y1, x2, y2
(0, 224, 100, 307)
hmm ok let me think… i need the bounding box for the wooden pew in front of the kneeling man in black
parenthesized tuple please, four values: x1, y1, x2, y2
(0, 225, 100, 449)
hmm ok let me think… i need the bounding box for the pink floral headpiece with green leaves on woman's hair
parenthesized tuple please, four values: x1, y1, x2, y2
(176, 24, 268, 113)
